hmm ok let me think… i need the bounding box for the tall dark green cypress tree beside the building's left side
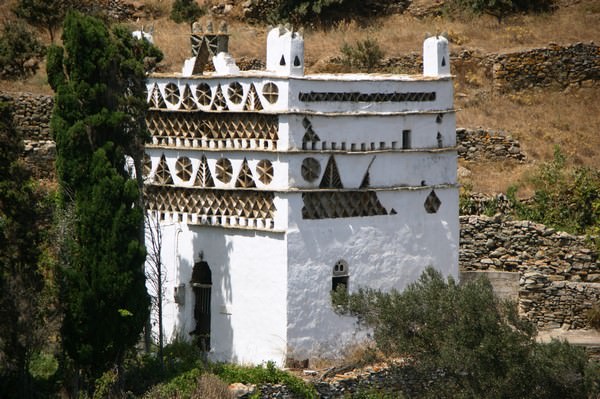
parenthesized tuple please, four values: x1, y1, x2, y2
(48, 12, 162, 390)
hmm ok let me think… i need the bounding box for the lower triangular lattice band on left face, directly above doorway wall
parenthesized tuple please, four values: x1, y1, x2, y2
(145, 185, 276, 219)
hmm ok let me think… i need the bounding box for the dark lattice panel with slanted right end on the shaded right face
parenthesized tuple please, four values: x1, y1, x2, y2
(302, 191, 388, 219)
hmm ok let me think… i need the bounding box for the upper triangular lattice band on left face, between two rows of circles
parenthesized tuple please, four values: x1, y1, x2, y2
(146, 111, 279, 148)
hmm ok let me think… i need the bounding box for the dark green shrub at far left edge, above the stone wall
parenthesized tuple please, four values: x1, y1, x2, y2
(0, 21, 45, 79)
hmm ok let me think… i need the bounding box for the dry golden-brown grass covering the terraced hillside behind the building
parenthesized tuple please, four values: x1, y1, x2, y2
(0, 0, 600, 192)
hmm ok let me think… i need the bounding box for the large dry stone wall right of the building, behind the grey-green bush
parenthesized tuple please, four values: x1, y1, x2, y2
(459, 215, 600, 329)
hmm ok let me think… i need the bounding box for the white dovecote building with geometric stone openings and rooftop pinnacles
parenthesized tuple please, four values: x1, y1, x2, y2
(145, 26, 459, 365)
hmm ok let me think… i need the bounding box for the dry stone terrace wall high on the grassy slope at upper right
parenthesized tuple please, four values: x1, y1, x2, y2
(486, 43, 600, 91)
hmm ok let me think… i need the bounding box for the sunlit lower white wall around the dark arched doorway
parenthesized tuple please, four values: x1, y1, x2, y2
(156, 224, 287, 365)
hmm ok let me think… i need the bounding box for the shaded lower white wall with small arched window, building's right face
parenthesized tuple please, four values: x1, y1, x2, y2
(287, 188, 459, 359)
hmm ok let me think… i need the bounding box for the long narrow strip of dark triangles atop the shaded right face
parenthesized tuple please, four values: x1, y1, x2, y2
(298, 91, 435, 103)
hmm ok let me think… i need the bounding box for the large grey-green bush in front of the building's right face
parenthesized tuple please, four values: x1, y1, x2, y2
(332, 269, 598, 399)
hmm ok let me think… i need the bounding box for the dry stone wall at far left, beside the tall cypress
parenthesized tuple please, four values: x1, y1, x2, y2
(0, 92, 56, 179)
